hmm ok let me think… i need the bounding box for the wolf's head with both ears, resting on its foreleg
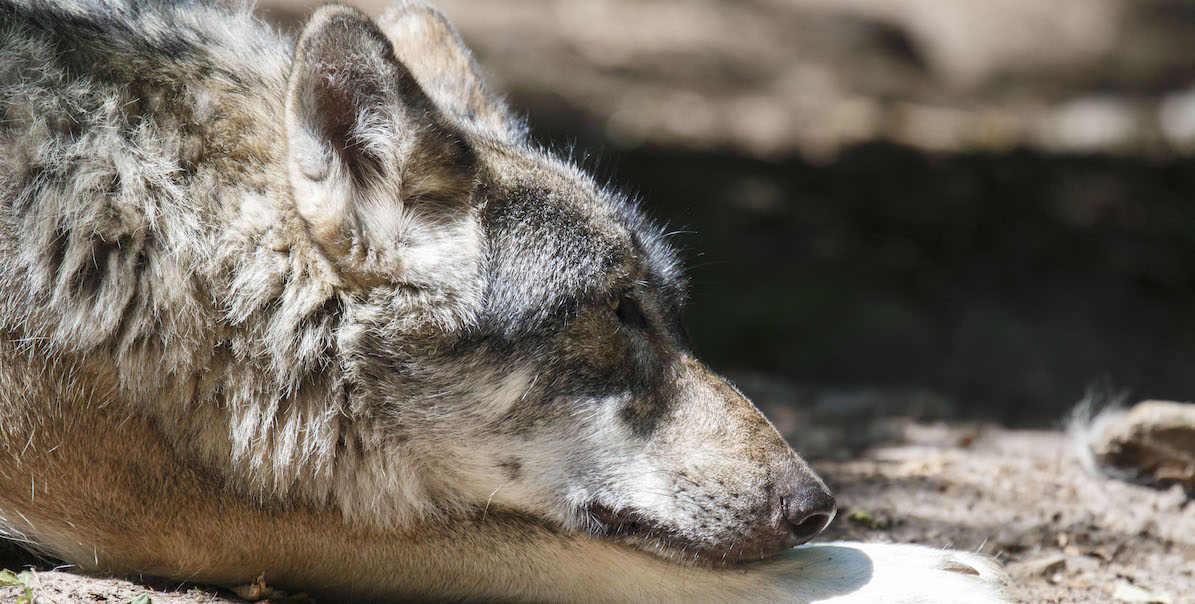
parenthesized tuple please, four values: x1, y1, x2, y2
(283, 4, 834, 563)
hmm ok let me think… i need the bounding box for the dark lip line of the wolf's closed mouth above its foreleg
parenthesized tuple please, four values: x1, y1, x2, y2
(584, 502, 793, 567)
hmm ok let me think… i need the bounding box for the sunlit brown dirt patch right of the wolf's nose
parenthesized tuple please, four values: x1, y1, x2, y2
(816, 422, 1195, 603)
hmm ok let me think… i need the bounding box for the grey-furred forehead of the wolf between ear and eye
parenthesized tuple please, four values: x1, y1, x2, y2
(477, 162, 686, 331)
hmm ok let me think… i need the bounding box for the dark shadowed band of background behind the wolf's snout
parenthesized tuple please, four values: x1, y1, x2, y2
(585, 144, 1195, 422)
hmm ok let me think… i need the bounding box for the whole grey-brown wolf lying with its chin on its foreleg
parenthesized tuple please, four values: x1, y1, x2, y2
(0, 0, 1012, 603)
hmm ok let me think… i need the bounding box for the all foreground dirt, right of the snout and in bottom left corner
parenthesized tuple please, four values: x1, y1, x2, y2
(0, 389, 1195, 604)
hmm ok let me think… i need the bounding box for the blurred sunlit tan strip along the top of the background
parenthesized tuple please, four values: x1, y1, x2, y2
(266, 0, 1195, 159)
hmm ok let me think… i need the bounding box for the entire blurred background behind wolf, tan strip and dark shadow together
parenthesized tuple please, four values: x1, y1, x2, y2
(264, 0, 1195, 426)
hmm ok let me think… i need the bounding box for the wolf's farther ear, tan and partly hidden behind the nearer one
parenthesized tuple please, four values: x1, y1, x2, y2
(378, 0, 527, 142)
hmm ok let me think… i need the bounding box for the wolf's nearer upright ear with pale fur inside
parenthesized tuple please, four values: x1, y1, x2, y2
(286, 5, 476, 263)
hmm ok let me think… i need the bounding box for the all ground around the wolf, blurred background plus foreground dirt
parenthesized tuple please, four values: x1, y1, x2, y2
(0, 0, 1195, 604)
